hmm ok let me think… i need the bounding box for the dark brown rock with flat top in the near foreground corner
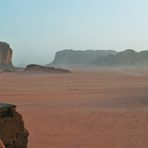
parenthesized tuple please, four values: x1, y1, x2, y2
(0, 103, 28, 148)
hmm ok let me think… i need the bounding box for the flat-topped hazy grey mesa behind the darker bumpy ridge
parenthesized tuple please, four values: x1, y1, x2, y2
(50, 49, 116, 67)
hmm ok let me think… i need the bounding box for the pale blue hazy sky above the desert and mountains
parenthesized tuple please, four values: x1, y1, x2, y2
(0, 0, 148, 64)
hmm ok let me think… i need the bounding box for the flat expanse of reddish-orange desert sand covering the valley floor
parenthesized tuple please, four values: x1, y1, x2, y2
(0, 71, 148, 148)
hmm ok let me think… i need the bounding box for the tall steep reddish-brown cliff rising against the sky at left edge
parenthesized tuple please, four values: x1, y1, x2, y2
(0, 42, 13, 69)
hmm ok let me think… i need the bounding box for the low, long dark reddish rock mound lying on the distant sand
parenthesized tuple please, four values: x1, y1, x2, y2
(25, 64, 70, 73)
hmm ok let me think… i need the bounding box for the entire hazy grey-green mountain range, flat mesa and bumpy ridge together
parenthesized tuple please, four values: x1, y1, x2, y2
(50, 49, 148, 68)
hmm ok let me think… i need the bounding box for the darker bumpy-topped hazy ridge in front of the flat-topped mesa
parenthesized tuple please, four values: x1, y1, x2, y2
(91, 49, 148, 66)
